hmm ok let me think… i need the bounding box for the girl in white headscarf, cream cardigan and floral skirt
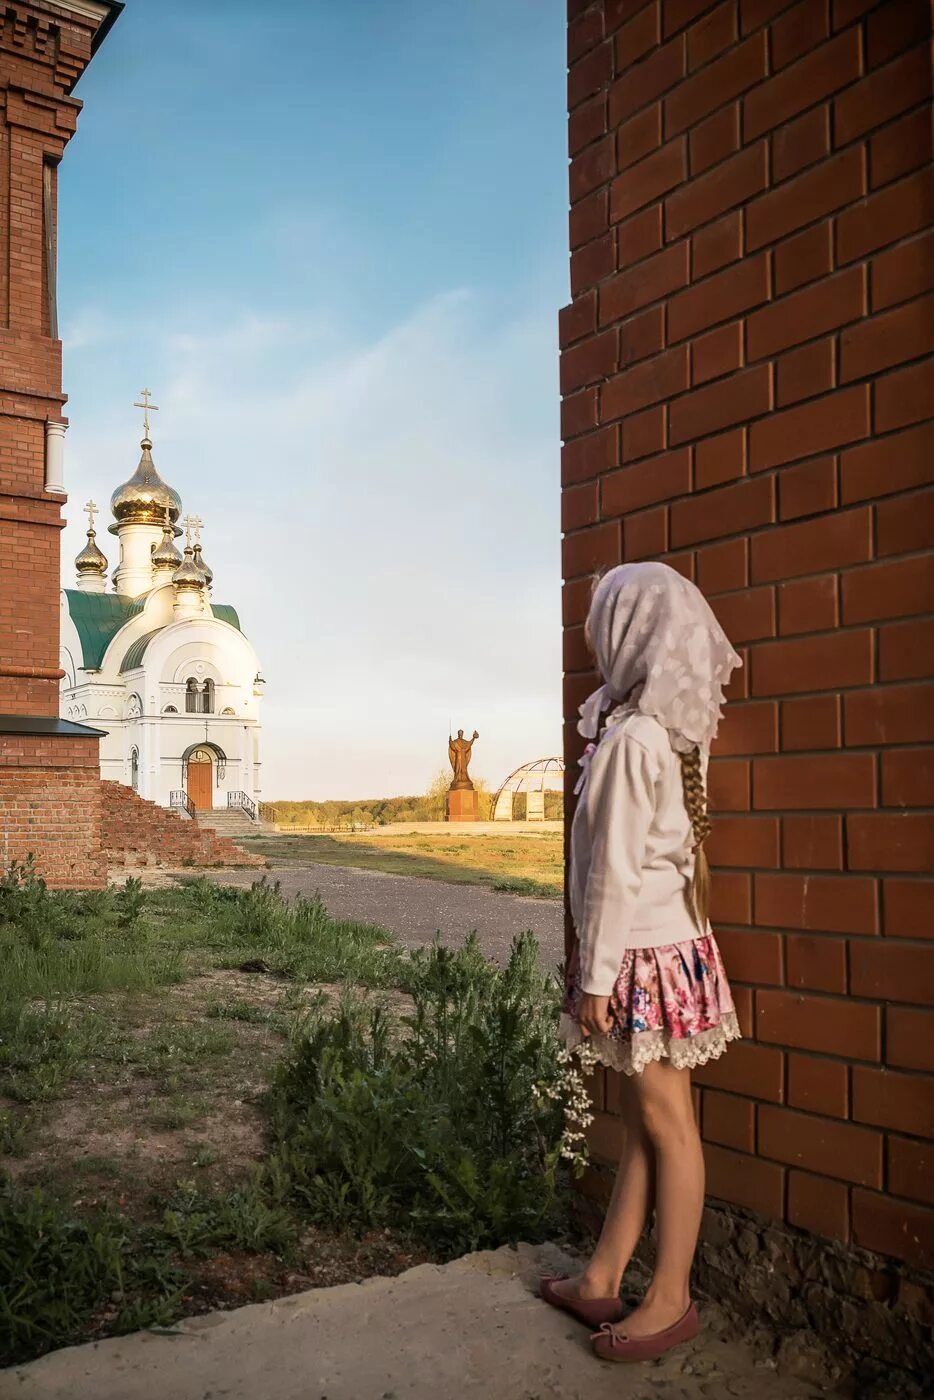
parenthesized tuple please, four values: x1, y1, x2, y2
(542, 563, 741, 1361)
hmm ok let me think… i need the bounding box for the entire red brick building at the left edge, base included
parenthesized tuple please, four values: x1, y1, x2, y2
(0, 0, 123, 886)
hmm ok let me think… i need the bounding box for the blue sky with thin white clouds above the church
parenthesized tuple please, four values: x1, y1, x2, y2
(59, 0, 567, 799)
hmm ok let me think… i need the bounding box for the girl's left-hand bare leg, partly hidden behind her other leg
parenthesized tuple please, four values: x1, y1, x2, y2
(555, 1075, 654, 1298)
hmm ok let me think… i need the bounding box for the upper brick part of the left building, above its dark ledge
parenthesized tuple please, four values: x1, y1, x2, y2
(0, 0, 106, 715)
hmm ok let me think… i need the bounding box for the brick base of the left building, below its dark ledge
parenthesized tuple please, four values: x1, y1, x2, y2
(0, 735, 106, 889)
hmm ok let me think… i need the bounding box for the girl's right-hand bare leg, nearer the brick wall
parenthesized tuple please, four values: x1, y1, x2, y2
(620, 1060, 704, 1337)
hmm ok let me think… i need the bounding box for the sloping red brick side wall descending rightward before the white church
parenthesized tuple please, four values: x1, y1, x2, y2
(101, 780, 266, 868)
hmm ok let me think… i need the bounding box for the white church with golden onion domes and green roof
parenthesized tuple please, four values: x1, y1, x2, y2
(62, 389, 263, 818)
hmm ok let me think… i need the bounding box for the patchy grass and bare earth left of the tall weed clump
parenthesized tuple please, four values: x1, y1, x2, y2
(0, 864, 420, 1364)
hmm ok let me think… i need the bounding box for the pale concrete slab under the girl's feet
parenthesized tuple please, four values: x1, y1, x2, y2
(0, 1245, 822, 1400)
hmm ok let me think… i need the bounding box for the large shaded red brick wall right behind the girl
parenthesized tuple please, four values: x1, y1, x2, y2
(560, 0, 934, 1263)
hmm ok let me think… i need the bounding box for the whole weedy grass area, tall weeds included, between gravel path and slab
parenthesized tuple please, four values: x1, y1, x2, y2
(0, 851, 576, 1365)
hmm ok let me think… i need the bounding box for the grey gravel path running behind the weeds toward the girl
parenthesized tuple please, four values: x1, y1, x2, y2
(201, 861, 564, 967)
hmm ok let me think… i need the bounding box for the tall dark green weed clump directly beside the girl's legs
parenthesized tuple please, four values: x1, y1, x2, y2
(264, 934, 564, 1257)
